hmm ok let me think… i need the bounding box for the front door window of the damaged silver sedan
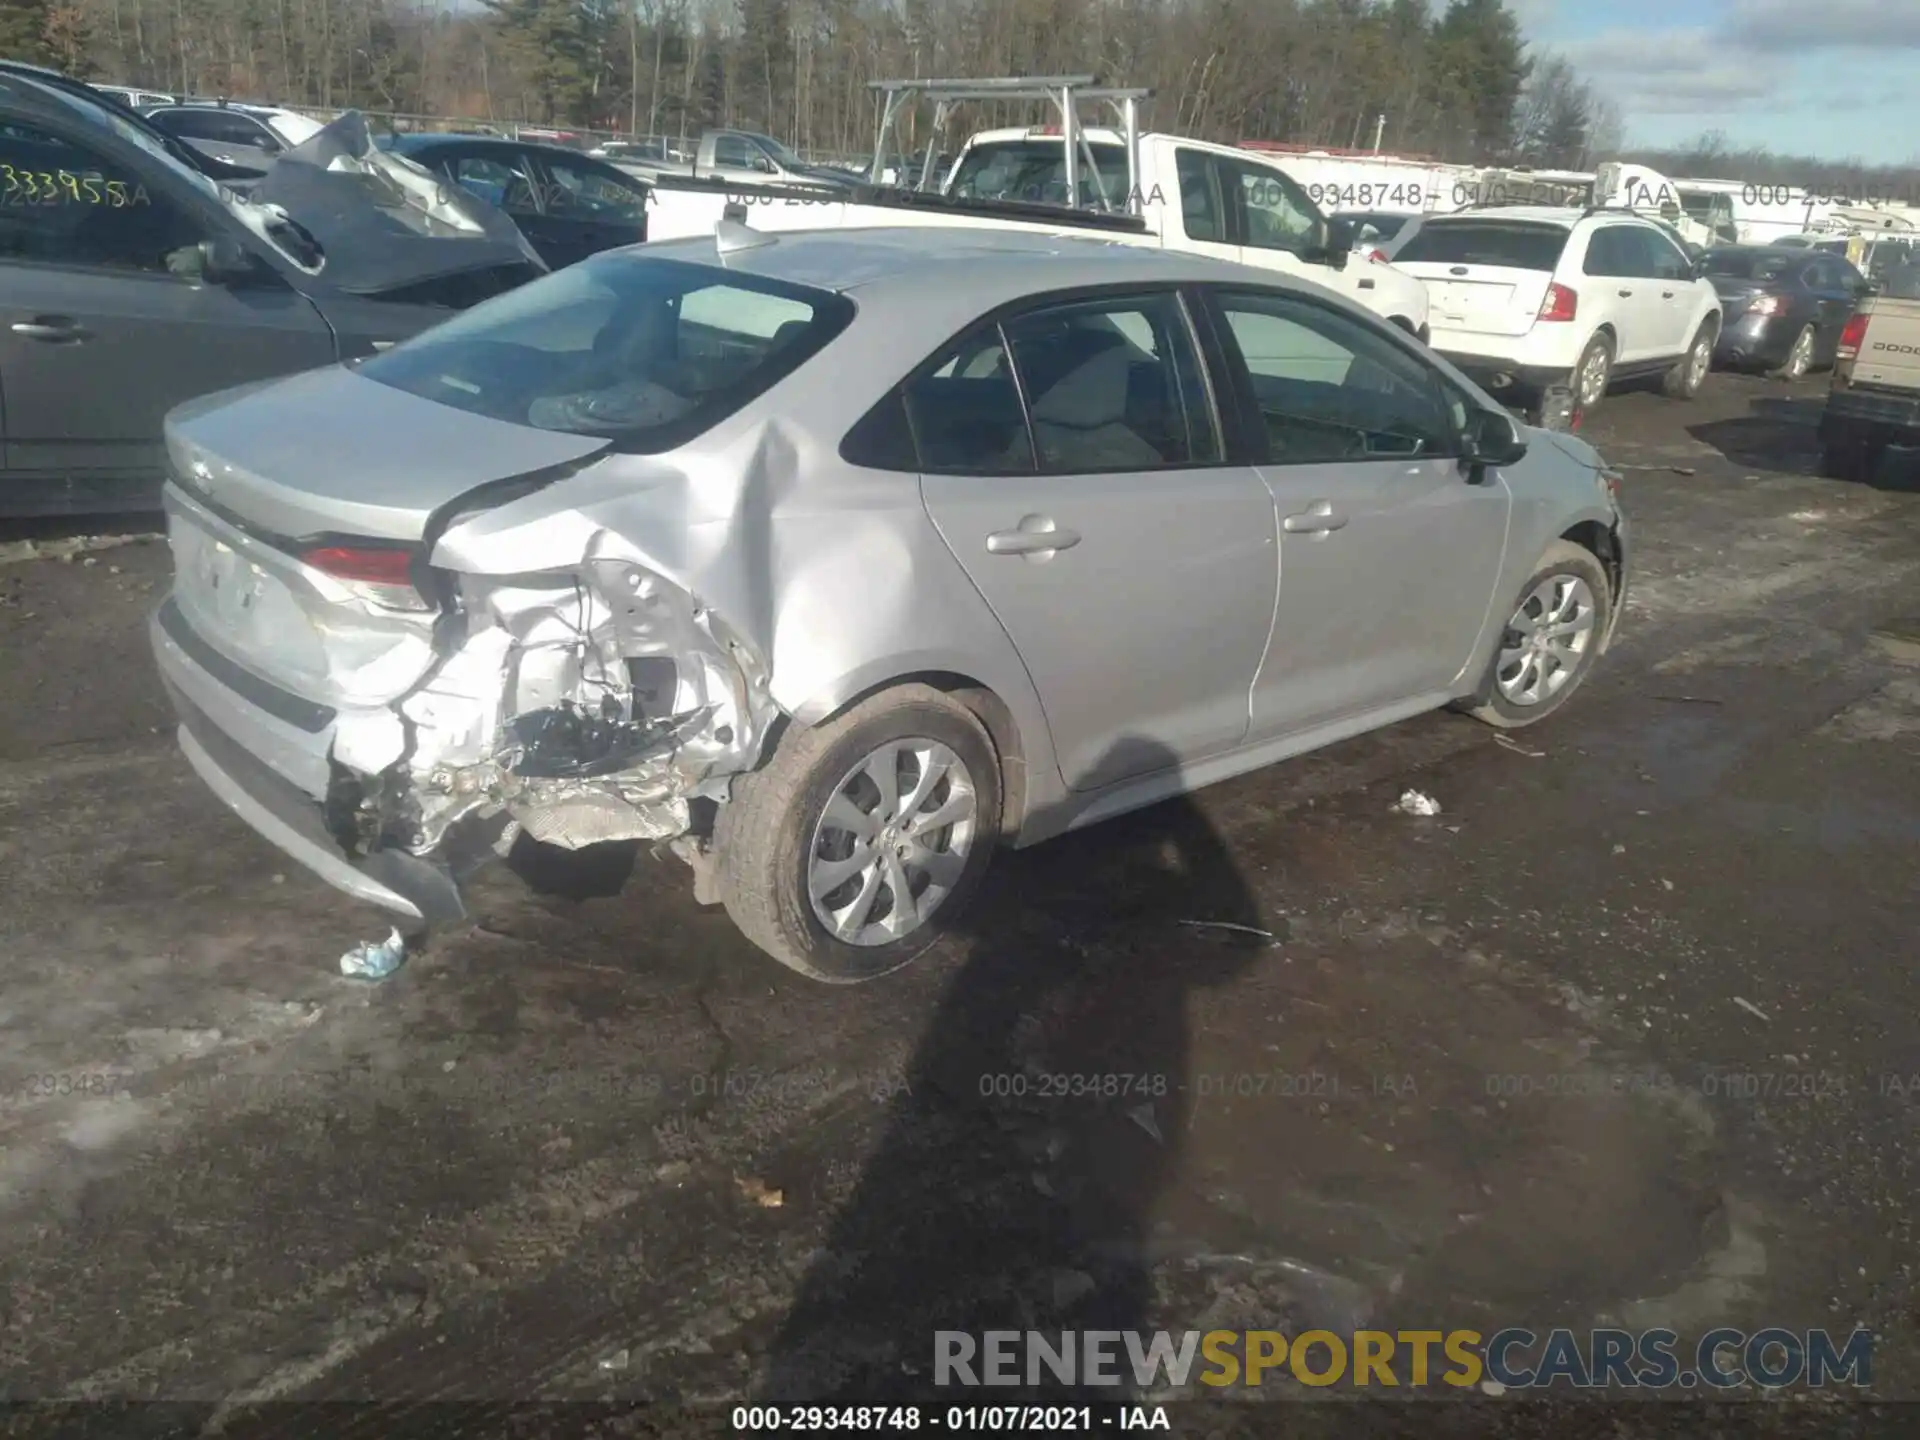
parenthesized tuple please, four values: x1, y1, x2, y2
(1219, 292, 1467, 465)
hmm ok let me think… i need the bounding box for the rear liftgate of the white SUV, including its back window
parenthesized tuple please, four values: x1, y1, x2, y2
(1394, 215, 1569, 344)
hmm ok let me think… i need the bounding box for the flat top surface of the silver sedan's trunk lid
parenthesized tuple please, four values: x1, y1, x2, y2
(167, 365, 609, 541)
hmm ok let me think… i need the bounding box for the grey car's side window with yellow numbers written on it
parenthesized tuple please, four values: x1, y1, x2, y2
(0, 121, 204, 275)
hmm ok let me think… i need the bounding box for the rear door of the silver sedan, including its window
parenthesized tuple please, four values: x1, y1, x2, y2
(906, 290, 1275, 791)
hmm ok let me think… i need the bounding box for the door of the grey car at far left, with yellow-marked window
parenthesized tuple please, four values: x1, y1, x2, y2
(0, 108, 334, 491)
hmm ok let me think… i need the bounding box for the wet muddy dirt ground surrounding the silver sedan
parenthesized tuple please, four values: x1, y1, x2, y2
(0, 376, 1920, 1427)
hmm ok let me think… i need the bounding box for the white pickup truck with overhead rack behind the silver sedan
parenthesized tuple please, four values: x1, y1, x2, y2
(647, 127, 1427, 340)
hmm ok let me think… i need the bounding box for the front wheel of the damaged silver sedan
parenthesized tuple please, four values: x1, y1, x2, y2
(1471, 540, 1613, 730)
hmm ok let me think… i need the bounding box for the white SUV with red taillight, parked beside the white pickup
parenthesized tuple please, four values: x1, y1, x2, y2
(1392, 205, 1720, 420)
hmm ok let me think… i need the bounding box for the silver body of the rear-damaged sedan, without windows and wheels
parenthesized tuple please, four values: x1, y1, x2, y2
(152, 228, 1626, 920)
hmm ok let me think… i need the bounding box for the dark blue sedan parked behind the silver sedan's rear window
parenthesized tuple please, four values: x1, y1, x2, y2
(390, 134, 649, 269)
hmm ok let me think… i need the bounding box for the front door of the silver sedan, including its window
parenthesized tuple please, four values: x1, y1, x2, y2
(1212, 288, 1511, 739)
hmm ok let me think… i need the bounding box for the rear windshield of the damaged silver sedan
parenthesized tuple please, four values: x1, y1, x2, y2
(359, 253, 852, 453)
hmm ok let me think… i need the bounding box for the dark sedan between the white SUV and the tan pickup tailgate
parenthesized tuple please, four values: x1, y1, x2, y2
(1705, 246, 1872, 380)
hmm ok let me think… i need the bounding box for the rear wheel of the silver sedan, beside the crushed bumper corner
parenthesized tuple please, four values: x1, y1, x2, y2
(714, 685, 1000, 985)
